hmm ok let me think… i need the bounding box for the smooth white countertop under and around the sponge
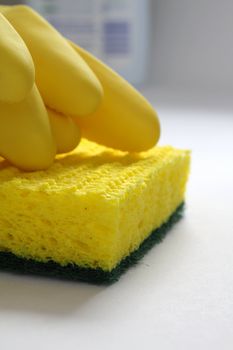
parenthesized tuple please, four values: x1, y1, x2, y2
(0, 89, 233, 350)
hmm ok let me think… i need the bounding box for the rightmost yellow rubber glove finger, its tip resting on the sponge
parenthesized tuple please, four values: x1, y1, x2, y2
(70, 42, 160, 152)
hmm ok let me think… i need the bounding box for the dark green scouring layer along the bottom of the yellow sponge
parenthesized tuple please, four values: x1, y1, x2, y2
(0, 203, 184, 285)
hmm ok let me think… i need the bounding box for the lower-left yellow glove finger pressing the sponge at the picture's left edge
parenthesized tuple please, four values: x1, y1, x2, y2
(0, 84, 56, 170)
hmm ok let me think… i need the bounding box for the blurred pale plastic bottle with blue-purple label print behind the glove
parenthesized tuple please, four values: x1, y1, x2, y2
(25, 0, 149, 85)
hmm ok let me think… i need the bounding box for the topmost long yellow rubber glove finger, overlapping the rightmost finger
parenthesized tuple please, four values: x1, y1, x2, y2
(2, 5, 103, 116)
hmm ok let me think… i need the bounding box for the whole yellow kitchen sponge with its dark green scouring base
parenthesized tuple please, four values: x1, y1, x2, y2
(0, 140, 190, 283)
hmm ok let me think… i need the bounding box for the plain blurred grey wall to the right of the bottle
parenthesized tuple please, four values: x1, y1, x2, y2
(149, 0, 233, 92)
